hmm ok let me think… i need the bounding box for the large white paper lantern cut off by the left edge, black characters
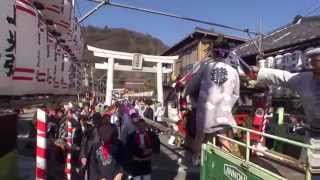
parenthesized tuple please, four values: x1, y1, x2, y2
(0, 0, 16, 95)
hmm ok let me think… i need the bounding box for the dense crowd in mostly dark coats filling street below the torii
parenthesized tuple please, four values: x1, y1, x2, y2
(34, 100, 163, 180)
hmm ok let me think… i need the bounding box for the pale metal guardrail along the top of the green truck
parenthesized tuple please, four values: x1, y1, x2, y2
(208, 126, 320, 180)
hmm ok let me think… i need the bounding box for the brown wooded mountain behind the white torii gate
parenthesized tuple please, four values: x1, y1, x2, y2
(83, 26, 167, 88)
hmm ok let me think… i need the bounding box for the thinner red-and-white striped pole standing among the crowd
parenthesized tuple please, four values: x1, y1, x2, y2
(65, 118, 72, 180)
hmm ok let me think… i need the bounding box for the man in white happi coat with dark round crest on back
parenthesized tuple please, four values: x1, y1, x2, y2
(186, 49, 240, 160)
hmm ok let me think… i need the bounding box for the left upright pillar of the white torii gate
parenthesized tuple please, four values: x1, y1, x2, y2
(105, 58, 114, 106)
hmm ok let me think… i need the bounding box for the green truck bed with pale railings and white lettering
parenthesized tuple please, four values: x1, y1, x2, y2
(201, 126, 320, 180)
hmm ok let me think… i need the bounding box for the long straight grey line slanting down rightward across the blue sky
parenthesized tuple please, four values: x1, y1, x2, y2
(85, 0, 259, 35)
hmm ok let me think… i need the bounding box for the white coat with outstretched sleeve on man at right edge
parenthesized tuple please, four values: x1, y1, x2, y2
(257, 68, 320, 128)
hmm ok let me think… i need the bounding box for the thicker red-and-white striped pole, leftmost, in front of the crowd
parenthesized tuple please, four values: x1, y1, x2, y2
(36, 109, 47, 180)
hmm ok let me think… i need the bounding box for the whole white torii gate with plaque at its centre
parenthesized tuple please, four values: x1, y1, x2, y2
(87, 46, 179, 105)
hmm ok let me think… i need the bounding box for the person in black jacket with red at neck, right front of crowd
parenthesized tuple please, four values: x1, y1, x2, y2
(126, 118, 160, 180)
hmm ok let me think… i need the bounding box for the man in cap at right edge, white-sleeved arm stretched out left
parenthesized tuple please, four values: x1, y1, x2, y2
(254, 48, 320, 166)
